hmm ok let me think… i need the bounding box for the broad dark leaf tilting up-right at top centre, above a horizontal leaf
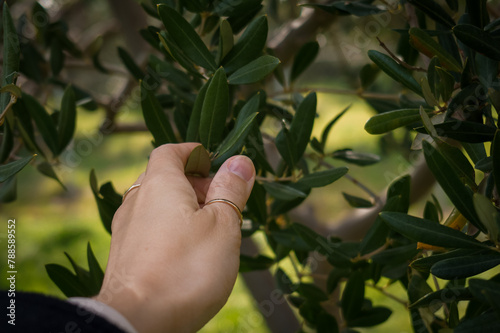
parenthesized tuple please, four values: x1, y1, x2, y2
(222, 16, 268, 73)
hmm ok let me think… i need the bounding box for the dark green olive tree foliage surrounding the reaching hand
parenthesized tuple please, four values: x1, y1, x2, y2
(0, 0, 500, 332)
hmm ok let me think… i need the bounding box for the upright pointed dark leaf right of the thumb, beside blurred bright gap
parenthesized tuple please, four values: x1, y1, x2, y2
(290, 92, 317, 163)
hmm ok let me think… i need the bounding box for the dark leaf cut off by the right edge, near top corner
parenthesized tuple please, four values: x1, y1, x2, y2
(453, 24, 500, 61)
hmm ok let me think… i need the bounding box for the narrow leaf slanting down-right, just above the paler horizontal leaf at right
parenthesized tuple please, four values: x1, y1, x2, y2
(368, 50, 423, 96)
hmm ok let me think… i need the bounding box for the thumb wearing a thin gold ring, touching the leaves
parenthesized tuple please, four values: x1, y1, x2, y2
(205, 155, 255, 223)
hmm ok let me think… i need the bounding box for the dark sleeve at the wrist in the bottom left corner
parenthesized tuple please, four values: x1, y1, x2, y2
(0, 291, 125, 333)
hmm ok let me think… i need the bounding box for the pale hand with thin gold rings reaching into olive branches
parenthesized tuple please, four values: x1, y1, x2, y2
(96, 143, 255, 333)
